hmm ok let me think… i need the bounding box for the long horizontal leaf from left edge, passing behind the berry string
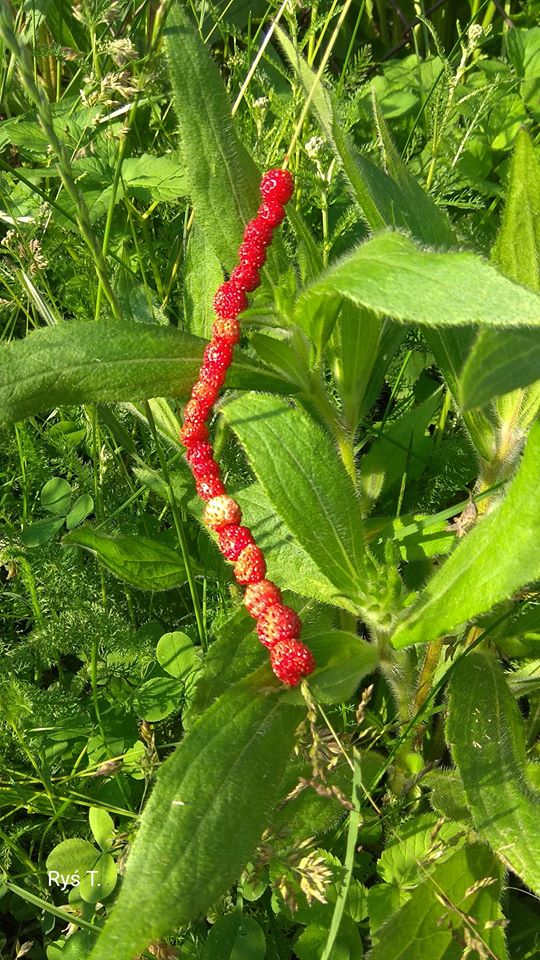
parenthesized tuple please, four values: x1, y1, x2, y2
(0, 321, 294, 421)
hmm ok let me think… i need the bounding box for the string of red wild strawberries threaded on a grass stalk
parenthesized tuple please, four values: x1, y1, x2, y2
(180, 170, 315, 687)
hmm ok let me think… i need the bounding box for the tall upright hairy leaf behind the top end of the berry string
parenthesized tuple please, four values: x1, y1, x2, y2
(163, 3, 260, 270)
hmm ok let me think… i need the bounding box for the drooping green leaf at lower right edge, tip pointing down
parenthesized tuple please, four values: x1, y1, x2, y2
(447, 649, 540, 894)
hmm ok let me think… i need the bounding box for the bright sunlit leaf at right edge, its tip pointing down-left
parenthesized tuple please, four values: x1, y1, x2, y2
(392, 423, 540, 647)
